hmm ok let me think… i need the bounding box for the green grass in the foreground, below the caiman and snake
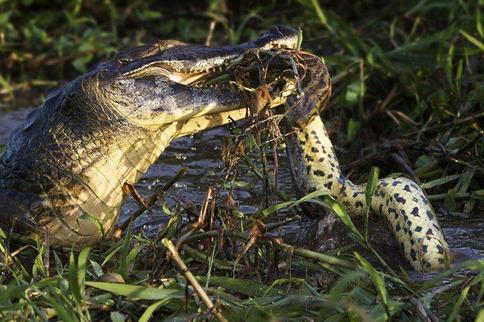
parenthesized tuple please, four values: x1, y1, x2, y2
(0, 210, 484, 321)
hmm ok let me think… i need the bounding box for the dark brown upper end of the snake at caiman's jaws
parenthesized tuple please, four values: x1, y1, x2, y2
(285, 51, 331, 128)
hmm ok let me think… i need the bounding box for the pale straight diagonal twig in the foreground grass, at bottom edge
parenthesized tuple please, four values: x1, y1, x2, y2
(161, 238, 228, 322)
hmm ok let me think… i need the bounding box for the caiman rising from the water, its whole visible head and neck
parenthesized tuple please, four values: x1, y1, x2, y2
(0, 27, 298, 245)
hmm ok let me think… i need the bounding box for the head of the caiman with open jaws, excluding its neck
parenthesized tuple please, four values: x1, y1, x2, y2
(79, 26, 298, 127)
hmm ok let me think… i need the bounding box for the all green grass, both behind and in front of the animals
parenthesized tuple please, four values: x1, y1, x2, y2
(0, 0, 484, 321)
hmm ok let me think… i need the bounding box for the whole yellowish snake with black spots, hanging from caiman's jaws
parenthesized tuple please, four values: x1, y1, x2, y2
(287, 54, 449, 271)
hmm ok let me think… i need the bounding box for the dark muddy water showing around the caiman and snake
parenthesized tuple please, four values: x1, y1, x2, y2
(0, 109, 484, 257)
